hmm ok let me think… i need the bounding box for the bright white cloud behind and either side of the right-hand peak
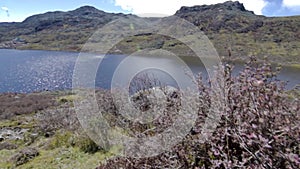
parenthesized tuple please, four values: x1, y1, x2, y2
(115, 0, 266, 15)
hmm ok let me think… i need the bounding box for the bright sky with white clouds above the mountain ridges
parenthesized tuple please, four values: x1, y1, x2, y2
(0, 0, 300, 22)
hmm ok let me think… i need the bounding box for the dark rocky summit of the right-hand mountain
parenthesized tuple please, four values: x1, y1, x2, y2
(175, 1, 265, 32)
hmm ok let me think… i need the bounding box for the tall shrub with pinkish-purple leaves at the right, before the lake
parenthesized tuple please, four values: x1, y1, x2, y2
(207, 59, 300, 168)
